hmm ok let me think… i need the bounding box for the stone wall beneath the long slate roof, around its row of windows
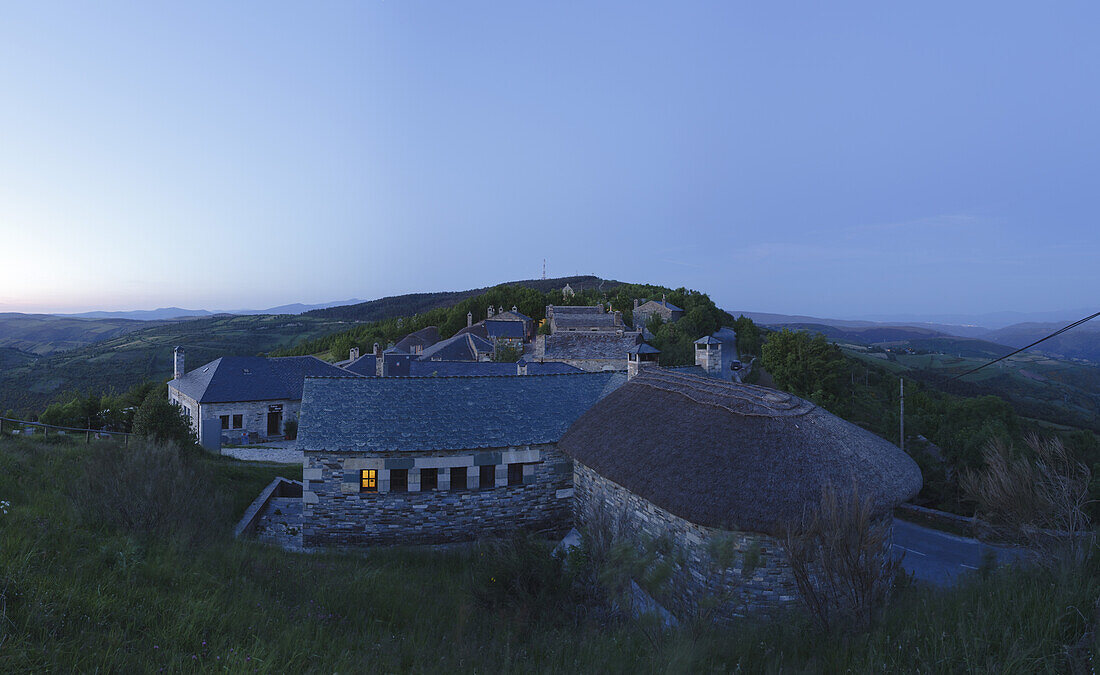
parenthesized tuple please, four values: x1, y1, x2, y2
(303, 444, 573, 546)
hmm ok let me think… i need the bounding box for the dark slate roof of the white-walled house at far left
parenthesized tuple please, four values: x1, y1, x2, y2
(168, 356, 348, 403)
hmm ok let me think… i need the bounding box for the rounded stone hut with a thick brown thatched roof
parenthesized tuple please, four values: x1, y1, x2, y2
(559, 368, 922, 617)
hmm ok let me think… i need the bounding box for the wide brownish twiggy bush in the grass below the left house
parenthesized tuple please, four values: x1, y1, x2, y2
(69, 442, 228, 541)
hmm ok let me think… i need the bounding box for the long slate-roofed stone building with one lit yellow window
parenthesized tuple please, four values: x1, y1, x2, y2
(298, 373, 625, 546)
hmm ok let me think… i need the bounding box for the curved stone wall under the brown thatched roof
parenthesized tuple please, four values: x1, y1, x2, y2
(573, 462, 798, 620)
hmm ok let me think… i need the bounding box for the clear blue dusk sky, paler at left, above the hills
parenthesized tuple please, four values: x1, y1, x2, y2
(0, 0, 1100, 318)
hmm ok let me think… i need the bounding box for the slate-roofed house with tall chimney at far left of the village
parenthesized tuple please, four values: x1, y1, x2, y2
(168, 347, 348, 449)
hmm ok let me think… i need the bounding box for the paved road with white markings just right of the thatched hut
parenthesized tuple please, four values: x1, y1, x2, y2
(893, 519, 1025, 586)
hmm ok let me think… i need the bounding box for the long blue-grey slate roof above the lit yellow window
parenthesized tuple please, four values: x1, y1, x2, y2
(298, 373, 624, 452)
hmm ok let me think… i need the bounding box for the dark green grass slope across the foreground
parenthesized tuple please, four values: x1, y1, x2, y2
(0, 440, 1100, 673)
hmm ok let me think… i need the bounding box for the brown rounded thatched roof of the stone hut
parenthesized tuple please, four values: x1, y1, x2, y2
(559, 368, 922, 534)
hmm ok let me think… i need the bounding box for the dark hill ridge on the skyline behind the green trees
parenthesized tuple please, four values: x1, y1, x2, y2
(304, 275, 622, 321)
